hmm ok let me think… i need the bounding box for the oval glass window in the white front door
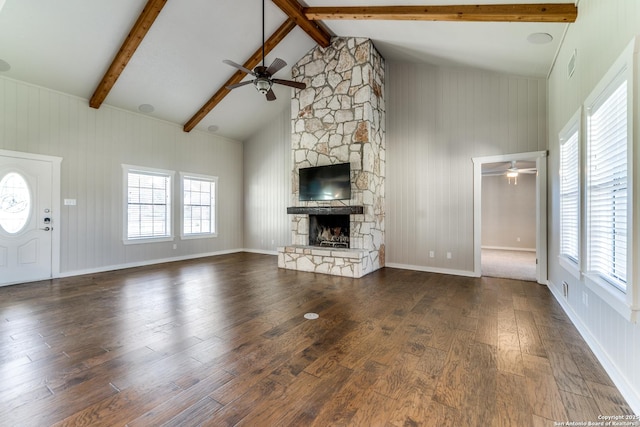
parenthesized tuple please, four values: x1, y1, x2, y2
(0, 172, 31, 234)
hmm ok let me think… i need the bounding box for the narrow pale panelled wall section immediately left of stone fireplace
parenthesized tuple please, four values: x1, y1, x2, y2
(244, 108, 292, 255)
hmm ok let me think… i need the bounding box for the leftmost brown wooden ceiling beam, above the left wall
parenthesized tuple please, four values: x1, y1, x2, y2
(89, 0, 167, 108)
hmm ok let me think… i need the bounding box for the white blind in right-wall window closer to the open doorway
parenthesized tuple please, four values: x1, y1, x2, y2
(560, 127, 580, 263)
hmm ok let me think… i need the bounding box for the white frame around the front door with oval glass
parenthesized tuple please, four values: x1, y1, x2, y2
(0, 149, 62, 278)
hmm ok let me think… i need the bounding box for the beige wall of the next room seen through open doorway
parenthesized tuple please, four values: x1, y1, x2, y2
(482, 174, 537, 251)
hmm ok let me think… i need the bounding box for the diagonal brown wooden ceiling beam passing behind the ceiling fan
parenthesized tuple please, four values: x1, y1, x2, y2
(183, 18, 296, 132)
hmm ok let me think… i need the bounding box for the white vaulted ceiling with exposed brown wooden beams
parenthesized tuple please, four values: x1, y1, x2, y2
(0, 0, 576, 140)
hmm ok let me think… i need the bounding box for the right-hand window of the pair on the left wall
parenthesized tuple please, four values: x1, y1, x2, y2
(180, 173, 218, 238)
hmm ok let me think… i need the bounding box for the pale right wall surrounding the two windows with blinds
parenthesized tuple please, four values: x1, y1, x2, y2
(548, 0, 640, 413)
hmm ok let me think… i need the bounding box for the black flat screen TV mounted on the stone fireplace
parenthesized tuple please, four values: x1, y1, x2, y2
(299, 163, 351, 200)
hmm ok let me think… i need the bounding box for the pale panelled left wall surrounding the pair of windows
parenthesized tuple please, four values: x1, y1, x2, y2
(0, 78, 243, 275)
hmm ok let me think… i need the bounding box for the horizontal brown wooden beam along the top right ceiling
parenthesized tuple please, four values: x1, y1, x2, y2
(302, 0, 578, 23)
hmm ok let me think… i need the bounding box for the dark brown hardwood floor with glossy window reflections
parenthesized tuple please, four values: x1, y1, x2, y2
(0, 253, 632, 427)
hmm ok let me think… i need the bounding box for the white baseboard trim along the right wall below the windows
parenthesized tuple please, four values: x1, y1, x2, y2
(547, 280, 640, 414)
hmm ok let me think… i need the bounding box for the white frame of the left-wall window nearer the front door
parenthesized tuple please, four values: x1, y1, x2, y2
(122, 164, 175, 245)
